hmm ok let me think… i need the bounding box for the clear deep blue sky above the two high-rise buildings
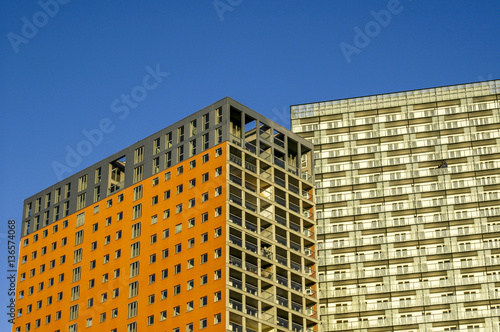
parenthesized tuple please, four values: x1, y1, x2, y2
(0, 0, 500, 331)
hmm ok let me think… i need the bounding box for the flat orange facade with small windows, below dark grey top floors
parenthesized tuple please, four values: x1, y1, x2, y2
(13, 143, 227, 332)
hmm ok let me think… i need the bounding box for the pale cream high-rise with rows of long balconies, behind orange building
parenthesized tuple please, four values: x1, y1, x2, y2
(291, 80, 500, 332)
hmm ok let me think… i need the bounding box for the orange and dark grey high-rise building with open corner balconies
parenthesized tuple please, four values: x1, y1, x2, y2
(13, 98, 319, 332)
